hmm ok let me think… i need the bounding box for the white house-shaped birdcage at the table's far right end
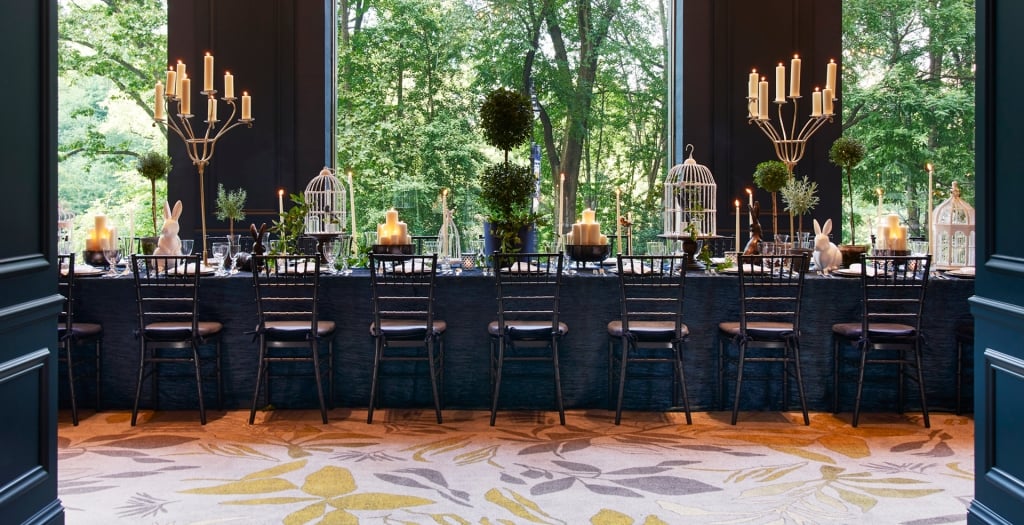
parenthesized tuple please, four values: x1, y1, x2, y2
(931, 182, 975, 268)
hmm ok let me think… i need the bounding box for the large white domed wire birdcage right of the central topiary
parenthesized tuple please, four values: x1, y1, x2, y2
(663, 144, 718, 238)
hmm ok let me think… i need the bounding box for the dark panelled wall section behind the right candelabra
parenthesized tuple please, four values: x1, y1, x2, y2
(677, 0, 843, 239)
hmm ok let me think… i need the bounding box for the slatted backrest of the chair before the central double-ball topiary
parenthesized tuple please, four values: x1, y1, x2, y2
(494, 252, 562, 334)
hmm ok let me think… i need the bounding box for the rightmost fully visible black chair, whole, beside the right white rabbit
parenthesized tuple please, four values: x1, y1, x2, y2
(833, 255, 932, 428)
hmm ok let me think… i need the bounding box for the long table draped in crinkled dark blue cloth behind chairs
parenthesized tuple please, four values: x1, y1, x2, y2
(68, 269, 974, 419)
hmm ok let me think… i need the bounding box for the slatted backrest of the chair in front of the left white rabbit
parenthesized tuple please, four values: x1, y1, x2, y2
(131, 254, 202, 338)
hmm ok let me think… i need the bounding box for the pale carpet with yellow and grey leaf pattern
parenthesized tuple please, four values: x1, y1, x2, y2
(58, 409, 974, 525)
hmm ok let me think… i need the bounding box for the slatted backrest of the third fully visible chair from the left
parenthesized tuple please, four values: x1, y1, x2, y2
(370, 254, 437, 337)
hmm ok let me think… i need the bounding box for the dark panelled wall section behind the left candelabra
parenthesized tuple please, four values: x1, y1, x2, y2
(167, 0, 334, 239)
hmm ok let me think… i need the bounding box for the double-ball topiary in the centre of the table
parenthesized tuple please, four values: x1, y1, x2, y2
(480, 88, 537, 253)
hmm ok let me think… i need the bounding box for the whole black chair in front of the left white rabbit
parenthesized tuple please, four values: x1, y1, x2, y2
(131, 254, 224, 427)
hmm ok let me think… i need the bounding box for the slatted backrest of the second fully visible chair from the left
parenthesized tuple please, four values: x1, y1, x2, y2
(253, 255, 321, 335)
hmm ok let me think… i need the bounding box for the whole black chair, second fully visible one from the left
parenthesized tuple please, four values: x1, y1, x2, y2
(249, 255, 335, 425)
